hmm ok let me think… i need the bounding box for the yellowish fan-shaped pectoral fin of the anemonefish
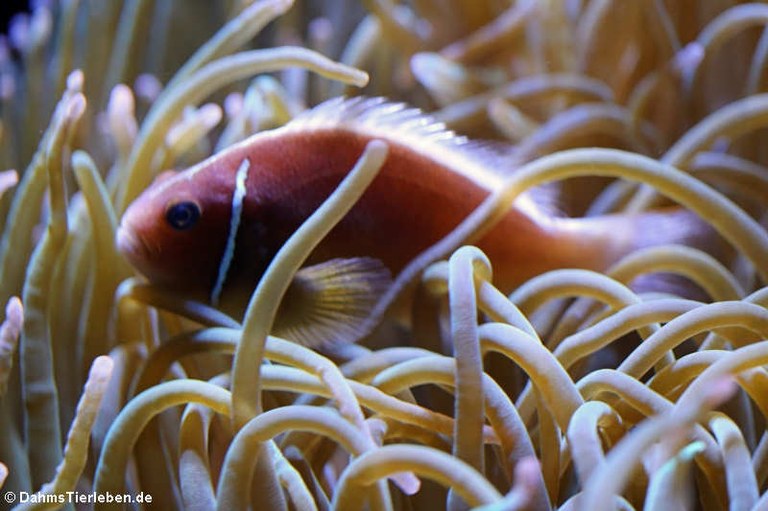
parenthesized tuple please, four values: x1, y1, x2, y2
(273, 257, 392, 347)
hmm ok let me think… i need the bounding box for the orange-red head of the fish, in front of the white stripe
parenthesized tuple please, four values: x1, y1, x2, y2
(117, 172, 232, 293)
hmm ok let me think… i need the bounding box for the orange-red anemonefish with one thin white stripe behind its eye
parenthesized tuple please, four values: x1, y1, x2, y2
(117, 98, 720, 344)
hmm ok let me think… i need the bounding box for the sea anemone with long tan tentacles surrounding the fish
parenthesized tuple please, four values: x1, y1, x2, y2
(0, 0, 768, 510)
